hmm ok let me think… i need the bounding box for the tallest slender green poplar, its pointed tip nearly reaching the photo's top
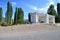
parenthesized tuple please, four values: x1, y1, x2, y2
(5, 2, 13, 25)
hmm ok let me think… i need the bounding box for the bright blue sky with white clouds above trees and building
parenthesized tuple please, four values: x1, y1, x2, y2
(0, 0, 60, 19)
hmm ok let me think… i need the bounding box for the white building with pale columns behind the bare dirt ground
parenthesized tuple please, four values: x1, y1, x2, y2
(30, 12, 55, 24)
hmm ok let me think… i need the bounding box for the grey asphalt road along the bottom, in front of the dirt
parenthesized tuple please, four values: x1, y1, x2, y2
(0, 30, 60, 40)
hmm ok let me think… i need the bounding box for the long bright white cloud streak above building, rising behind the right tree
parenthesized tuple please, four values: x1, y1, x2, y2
(28, 0, 57, 12)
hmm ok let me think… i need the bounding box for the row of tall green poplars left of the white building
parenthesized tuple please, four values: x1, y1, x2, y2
(0, 1, 24, 25)
